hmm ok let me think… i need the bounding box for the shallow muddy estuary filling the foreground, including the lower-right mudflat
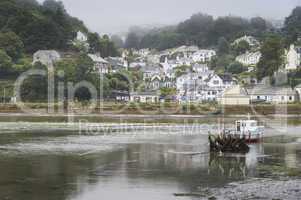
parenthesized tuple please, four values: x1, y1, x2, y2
(0, 126, 301, 200)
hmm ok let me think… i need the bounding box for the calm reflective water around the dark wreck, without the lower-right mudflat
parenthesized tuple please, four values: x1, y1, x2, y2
(0, 130, 301, 200)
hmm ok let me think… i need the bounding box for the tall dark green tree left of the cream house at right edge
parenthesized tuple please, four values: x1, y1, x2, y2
(256, 35, 284, 80)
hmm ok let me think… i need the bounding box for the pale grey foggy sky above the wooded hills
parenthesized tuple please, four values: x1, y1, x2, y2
(39, 0, 301, 34)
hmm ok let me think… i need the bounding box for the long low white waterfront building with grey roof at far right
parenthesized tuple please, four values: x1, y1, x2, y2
(248, 85, 297, 104)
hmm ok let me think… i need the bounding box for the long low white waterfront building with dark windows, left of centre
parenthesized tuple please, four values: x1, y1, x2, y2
(130, 92, 160, 103)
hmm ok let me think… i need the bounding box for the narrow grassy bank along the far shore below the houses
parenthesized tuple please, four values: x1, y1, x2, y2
(0, 102, 301, 115)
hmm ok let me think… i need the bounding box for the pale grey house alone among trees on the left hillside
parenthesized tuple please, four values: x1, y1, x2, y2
(33, 50, 61, 67)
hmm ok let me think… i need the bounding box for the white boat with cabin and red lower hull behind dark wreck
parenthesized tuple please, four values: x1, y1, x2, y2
(224, 119, 264, 143)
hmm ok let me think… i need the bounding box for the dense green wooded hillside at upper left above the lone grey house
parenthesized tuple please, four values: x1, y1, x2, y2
(0, 0, 119, 76)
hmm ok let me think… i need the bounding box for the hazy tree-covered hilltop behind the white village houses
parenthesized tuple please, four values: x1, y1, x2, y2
(124, 7, 301, 50)
